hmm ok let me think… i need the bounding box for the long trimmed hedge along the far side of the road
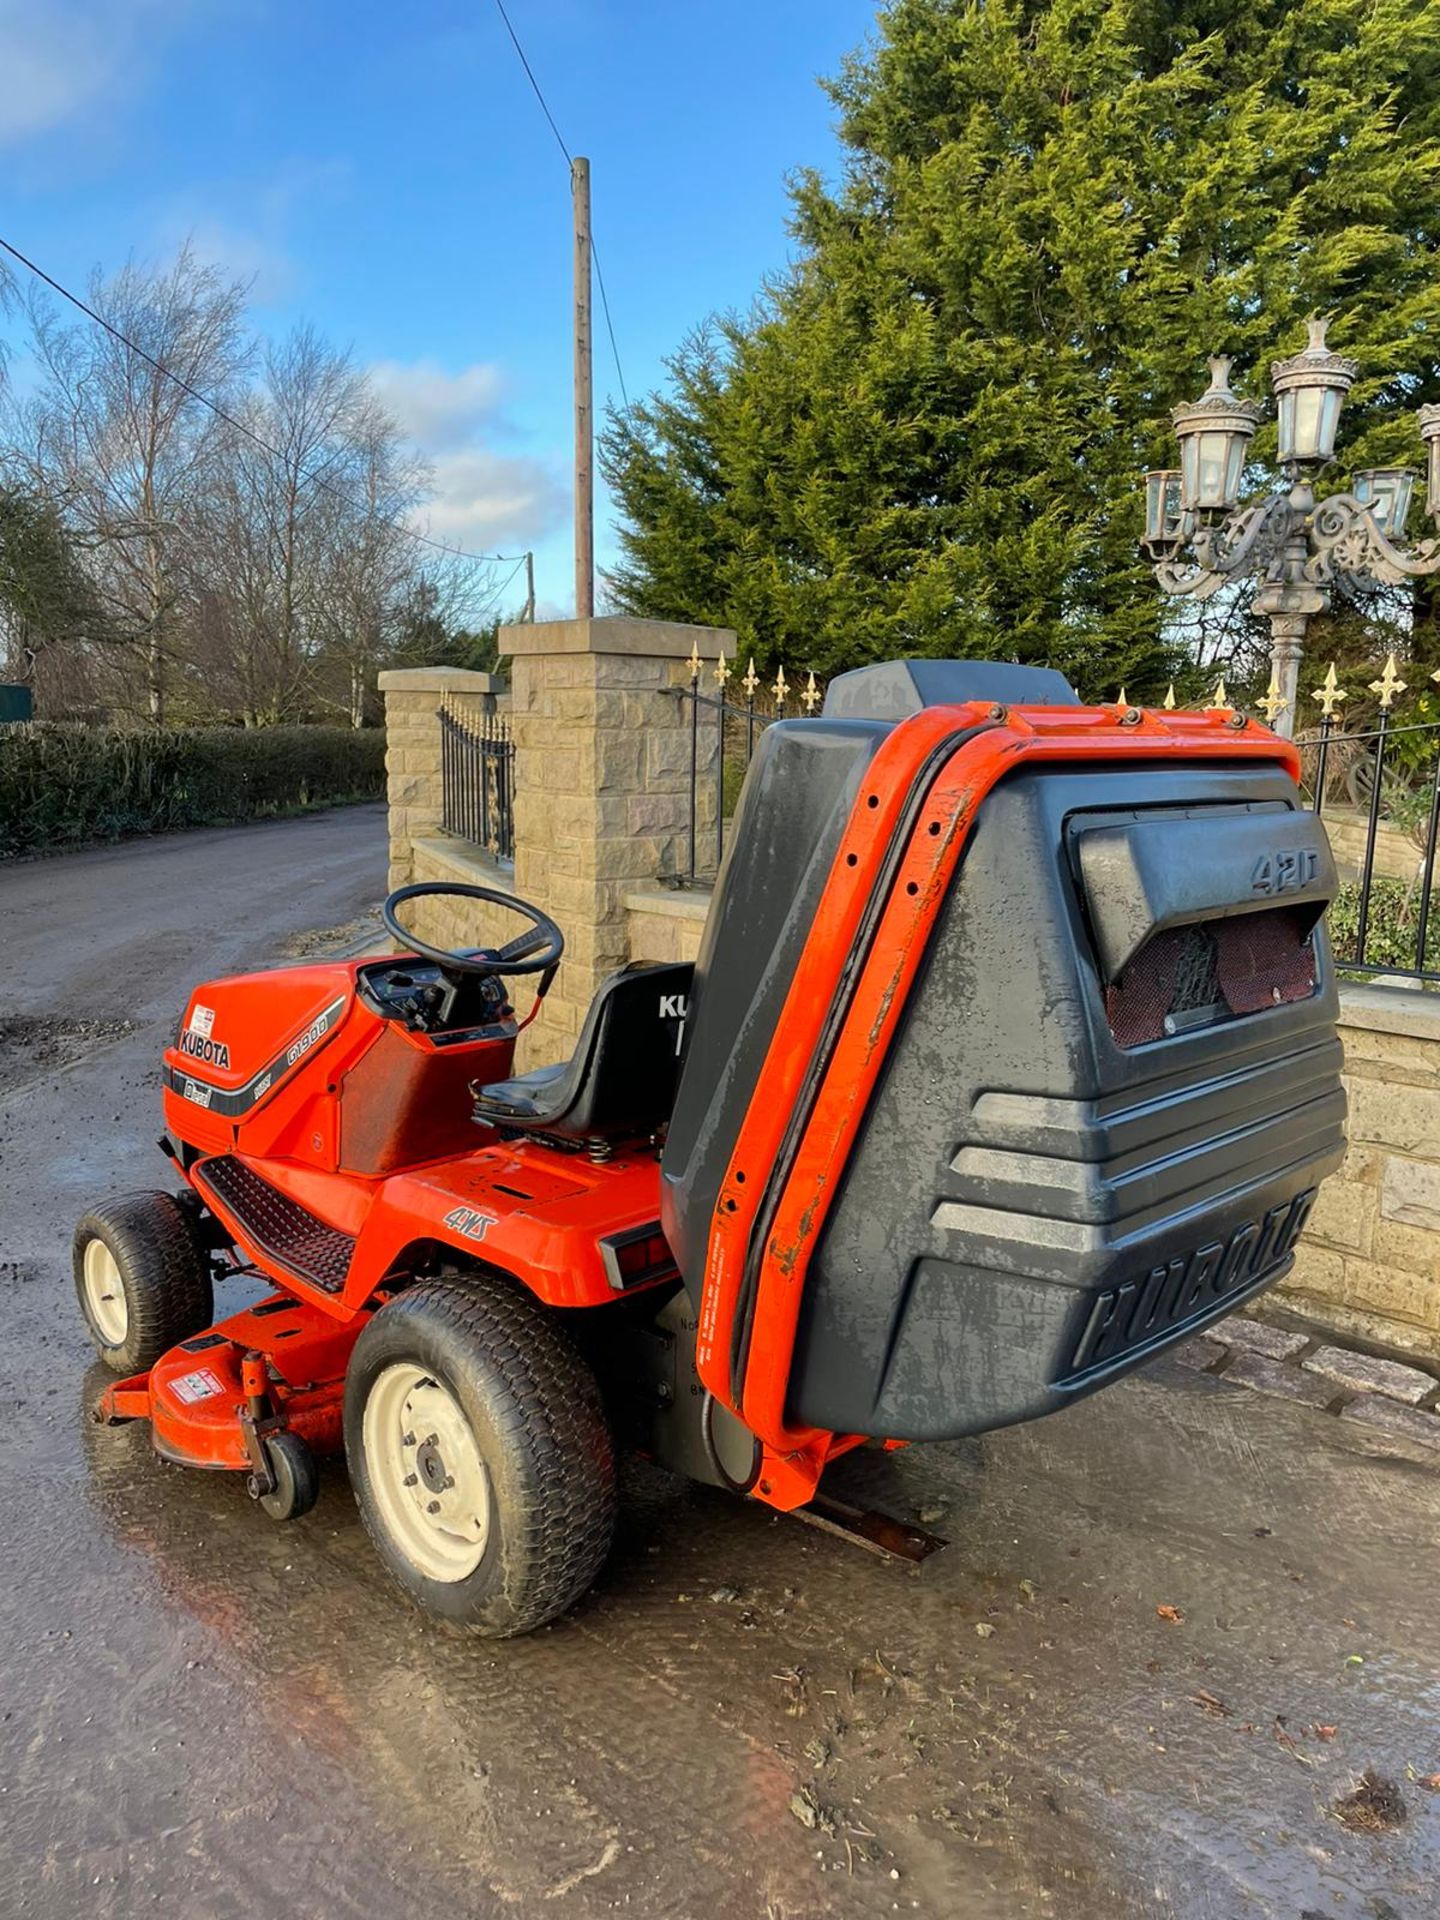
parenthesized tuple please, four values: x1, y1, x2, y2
(0, 724, 386, 858)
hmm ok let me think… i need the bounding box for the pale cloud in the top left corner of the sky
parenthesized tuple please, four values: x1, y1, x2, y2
(0, 0, 203, 146)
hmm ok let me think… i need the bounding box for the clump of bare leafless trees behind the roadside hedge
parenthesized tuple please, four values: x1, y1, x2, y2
(0, 248, 493, 726)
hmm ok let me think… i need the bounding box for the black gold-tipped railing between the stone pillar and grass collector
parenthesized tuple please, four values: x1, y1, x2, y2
(660, 649, 824, 887)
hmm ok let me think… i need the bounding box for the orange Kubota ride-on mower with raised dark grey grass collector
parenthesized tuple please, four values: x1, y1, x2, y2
(75, 660, 1344, 1634)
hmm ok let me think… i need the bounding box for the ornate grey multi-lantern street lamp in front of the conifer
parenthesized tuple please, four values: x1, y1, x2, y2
(1140, 319, 1440, 735)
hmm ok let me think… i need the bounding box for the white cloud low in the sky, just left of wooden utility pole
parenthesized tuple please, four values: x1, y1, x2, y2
(369, 359, 570, 553)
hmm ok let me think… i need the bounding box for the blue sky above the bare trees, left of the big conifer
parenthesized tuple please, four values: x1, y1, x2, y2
(0, 0, 876, 612)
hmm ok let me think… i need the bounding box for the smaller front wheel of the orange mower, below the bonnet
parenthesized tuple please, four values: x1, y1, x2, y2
(75, 1192, 215, 1373)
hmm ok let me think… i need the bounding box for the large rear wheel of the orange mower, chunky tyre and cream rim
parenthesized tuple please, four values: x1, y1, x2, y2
(346, 1279, 614, 1638)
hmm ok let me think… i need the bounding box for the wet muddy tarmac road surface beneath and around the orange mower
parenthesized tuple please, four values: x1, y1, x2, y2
(0, 808, 1440, 1920)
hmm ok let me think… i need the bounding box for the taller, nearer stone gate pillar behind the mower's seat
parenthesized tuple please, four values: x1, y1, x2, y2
(499, 618, 735, 1064)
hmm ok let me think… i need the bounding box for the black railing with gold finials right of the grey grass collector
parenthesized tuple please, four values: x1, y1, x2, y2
(1296, 655, 1440, 987)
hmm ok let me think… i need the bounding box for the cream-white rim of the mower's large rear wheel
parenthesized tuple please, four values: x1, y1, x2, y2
(361, 1361, 490, 1582)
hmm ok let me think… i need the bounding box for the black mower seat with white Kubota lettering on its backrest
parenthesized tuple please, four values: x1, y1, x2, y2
(474, 960, 695, 1140)
